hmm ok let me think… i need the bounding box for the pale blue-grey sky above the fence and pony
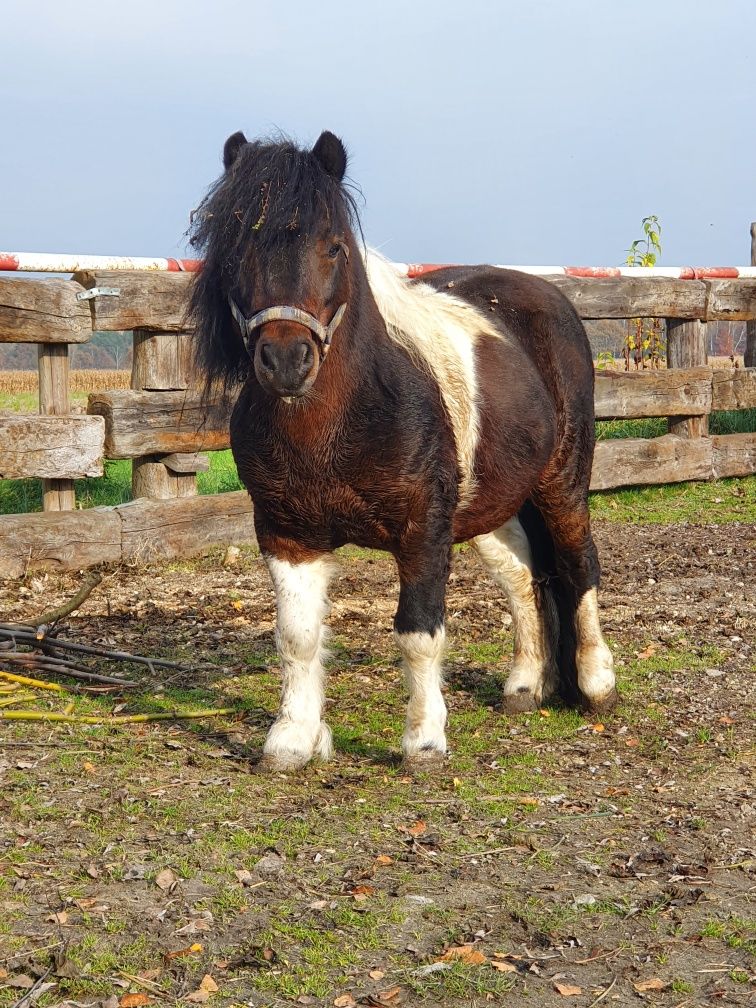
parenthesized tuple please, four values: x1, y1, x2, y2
(0, 0, 756, 265)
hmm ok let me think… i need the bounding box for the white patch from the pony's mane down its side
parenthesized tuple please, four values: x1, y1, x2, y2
(365, 250, 501, 506)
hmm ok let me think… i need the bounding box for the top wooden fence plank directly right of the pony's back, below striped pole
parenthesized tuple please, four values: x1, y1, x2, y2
(546, 276, 707, 319)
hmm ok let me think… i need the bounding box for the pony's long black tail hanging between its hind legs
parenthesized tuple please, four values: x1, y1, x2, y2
(517, 500, 580, 706)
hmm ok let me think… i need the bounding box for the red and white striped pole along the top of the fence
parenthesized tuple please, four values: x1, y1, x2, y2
(0, 252, 756, 280)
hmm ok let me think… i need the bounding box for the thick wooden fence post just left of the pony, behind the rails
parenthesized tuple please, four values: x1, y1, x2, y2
(131, 329, 208, 500)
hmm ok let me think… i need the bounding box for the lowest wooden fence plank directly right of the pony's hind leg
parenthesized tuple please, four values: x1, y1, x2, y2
(591, 434, 712, 490)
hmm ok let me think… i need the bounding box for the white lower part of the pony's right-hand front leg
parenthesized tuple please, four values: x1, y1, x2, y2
(394, 627, 447, 759)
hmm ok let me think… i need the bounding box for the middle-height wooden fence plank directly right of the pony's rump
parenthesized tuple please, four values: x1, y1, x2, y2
(595, 368, 712, 419)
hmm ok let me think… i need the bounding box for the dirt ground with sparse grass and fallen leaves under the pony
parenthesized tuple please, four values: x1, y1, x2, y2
(0, 522, 756, 1008)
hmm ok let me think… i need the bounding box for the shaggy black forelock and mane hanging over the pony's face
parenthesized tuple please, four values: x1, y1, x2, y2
(187, 139, 359, 387)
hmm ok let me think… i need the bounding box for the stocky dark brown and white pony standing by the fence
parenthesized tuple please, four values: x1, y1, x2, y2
(191, 132, 616, 770)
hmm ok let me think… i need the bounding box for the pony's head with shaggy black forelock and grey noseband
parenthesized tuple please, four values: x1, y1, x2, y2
(191, 132, 357, 400)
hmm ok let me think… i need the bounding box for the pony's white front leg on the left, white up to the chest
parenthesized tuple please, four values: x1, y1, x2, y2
(263, 556, 335, 770)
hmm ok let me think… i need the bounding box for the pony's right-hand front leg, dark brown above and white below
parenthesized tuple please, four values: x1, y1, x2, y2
(394, 546, 449, 769)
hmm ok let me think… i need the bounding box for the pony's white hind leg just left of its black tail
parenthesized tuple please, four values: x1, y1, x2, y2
(473, 518, 557, 704)
